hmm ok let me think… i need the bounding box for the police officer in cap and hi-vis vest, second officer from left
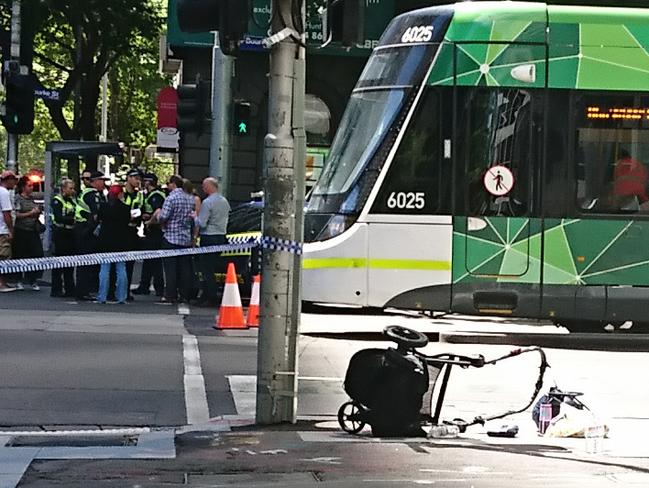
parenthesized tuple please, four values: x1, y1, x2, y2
(74, 171, 108, 301)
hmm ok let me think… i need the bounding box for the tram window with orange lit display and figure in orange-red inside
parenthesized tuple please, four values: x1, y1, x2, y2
(575, 94, 649, 214)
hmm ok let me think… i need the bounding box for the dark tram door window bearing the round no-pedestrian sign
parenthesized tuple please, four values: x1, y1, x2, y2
(460, 88, 534, 216)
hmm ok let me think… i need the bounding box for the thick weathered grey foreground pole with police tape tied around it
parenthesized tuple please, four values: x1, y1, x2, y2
(256, 0, 306, 424)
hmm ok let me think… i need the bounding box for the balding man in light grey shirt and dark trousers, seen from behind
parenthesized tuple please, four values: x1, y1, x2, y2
(198, 177, 230, 306)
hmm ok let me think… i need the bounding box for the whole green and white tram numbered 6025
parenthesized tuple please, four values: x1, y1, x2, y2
(303, 1, 649, 331)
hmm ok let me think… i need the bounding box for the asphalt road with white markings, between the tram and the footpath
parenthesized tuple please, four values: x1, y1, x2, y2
(0, 288, 649, 428)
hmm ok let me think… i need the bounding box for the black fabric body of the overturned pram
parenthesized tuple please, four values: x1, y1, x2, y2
(345, 349, 429, 436)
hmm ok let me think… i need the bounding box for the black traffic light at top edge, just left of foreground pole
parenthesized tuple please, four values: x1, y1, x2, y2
(177, 0, 252, 54)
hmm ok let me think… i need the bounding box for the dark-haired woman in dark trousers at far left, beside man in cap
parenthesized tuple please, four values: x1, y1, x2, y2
(12, 176, 45, 291)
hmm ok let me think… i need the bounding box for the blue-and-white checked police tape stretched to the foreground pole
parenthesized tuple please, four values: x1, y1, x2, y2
(0, 237, 302, 274)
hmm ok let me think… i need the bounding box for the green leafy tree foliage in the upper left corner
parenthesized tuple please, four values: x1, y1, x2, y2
(0, 0, 169, 168)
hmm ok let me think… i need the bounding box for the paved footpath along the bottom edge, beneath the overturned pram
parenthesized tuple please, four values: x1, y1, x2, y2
(0, 417, 649, 488)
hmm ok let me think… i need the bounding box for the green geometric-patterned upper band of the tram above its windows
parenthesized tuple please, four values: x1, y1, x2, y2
(404, 1, 649, 91)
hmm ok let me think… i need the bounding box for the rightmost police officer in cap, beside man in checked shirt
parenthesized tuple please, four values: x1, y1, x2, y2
(133, 173, 166, 297)
